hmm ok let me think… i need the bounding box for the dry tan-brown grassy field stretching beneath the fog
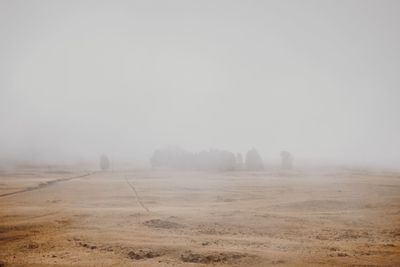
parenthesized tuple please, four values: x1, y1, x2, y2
(0, 167, 400, 266)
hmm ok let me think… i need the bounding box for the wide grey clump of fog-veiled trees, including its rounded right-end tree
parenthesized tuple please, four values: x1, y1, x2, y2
(150, 147, 264, 171)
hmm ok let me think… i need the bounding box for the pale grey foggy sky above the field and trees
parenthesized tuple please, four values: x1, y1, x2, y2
(0, 0, 400, 166)
